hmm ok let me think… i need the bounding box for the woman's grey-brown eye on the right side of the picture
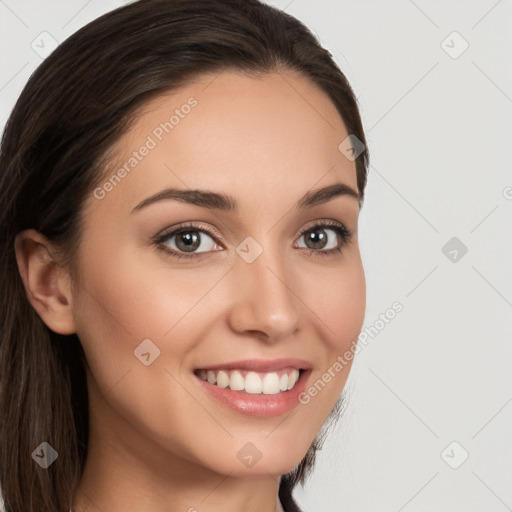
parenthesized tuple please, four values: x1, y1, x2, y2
(299, 221, 354, 256)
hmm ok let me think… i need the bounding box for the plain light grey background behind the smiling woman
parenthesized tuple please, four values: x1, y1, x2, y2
(0, 0, 512, 512)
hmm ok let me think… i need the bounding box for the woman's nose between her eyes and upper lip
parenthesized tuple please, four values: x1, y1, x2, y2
(229, 241, 302, 343)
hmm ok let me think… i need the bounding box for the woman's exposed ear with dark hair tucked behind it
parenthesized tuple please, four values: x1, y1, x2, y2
(14, 229, 76, 334)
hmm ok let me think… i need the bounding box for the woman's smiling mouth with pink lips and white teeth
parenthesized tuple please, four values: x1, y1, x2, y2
(194, 359, 312, 417)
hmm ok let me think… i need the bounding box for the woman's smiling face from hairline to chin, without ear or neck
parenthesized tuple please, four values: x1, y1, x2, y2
(73, 71, 365, 476)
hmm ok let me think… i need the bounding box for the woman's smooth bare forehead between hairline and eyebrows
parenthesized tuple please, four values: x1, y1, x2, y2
(90, 71, 357, 214)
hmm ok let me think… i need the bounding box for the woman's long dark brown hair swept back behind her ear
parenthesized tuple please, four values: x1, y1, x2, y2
(0, 0, 368, 512)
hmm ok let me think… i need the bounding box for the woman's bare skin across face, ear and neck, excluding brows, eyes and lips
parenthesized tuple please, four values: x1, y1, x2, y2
(16, 71, 365, 512)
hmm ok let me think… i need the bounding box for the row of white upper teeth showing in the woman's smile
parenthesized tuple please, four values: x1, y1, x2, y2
(198, 368, 300, 395)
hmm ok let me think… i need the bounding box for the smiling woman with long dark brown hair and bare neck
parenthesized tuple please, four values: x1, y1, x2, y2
(0, 0, 368, 512)
